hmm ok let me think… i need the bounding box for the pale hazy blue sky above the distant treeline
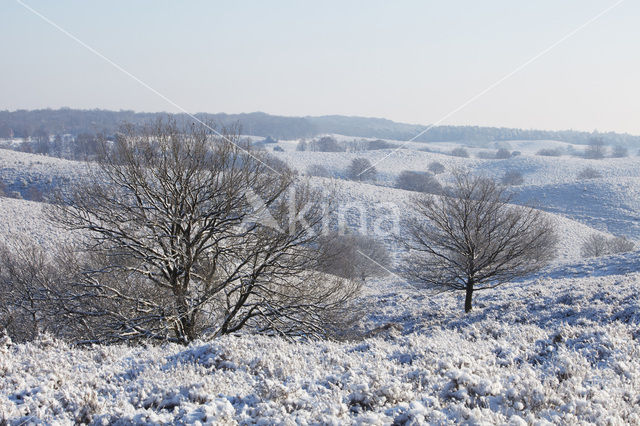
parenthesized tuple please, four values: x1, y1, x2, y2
(0, 0, 640, 134)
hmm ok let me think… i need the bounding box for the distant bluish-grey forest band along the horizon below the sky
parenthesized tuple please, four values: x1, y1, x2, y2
(0, 108, 640, 146)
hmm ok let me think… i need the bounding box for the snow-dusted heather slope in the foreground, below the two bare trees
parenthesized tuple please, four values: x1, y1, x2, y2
(0, 253, 640, 425)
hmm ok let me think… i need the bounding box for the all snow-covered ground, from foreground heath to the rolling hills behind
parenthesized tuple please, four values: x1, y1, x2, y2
(0, 139, 640, 425)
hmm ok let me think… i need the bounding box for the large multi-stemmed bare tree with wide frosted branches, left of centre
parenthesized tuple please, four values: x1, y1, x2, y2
(50, 121, 358, 343)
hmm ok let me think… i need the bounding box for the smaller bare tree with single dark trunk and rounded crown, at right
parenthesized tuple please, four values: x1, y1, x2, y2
(400, 172, 556, 312)
